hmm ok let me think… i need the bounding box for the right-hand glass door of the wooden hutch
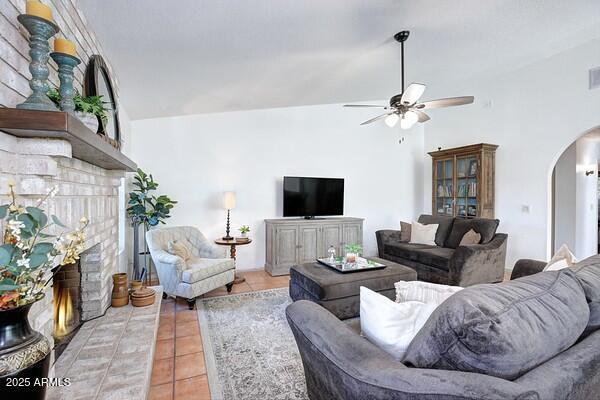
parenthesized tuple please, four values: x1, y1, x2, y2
(456, 156, 479, 218)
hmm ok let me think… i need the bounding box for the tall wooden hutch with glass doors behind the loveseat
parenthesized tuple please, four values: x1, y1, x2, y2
(429, 143, 498, 218)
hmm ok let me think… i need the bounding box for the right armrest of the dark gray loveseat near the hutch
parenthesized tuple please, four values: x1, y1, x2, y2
(449, 233, 508, 287)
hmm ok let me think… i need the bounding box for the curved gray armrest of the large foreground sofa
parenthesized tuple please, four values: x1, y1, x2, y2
(286, 300, 538, 400)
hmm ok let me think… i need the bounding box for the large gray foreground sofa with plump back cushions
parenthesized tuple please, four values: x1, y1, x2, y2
(286, 256, 600, 400)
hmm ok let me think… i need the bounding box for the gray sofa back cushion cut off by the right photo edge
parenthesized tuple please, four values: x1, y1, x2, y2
(573, 255, 600, 334)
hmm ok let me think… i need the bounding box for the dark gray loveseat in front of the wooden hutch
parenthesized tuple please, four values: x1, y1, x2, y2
(375, 214, 508, 287)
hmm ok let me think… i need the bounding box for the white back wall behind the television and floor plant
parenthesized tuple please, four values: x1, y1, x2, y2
(131, 104, 423, 269)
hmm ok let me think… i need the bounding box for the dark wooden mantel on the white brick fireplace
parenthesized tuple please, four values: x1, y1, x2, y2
(0, 108, 137, 171)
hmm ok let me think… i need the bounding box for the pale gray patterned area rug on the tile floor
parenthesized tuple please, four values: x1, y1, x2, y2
(196, 288, 308, 400)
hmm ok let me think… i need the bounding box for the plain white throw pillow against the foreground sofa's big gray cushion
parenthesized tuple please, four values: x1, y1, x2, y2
(360, 286, 436, 361)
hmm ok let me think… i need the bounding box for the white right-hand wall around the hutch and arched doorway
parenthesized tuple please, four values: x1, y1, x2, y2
(424, 39, 600, 268)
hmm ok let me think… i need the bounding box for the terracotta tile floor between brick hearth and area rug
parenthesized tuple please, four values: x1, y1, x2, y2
(148, 270, 289, 400)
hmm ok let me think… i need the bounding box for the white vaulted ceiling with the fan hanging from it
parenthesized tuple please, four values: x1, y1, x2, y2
(80, 0, 600, 119)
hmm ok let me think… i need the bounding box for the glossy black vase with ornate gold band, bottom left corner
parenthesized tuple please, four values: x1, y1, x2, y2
(0, 303, 51, 400)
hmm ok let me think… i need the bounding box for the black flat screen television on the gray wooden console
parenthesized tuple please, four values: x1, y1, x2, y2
(283, 176, 344, 218)
